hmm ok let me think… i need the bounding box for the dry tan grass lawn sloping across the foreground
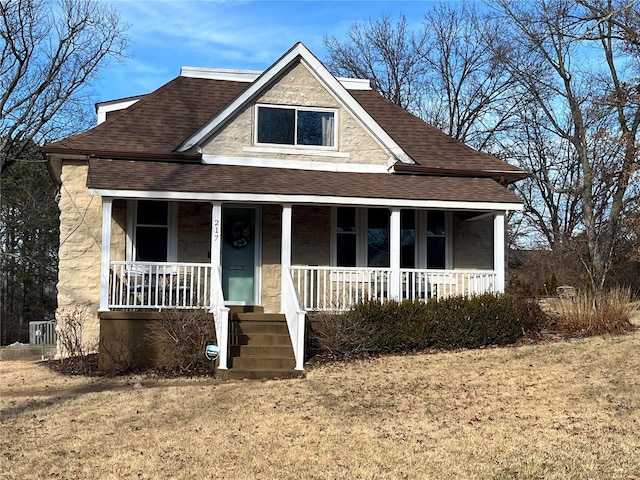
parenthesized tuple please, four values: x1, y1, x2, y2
(0, 310, 640, 480)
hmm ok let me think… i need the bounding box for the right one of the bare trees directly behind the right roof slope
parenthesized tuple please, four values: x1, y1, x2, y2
(420, 2, 522, 150)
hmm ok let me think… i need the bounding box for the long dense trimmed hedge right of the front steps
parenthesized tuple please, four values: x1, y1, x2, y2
(312, 294, 533, 355)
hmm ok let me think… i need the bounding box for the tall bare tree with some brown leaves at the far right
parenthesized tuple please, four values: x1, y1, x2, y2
(493, 0, 640, 291)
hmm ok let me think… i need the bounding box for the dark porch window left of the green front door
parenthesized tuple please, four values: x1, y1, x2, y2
(134, 200, 169, 262)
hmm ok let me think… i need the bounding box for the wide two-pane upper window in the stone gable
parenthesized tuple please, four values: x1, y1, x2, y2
(256, 105, 336, 147)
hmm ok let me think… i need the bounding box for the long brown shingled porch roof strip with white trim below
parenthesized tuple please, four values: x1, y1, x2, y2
(87, 158, 522, 209)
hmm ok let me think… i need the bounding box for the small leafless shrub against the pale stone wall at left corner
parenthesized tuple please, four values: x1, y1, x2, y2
(56, 305, 97, 374)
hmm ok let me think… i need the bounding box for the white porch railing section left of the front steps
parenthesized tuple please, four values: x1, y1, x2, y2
(109, 260, 211, 310)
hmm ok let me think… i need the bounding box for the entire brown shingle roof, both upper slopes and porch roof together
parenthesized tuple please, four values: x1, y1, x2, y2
(42, 66, 524, 203)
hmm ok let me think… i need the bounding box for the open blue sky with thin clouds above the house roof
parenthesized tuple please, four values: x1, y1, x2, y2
(95, 0, 456, 101)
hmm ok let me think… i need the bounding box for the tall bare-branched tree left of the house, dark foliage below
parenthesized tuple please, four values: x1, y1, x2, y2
(0, 0, 126, 342)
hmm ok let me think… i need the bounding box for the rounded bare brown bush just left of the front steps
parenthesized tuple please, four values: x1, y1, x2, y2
(145, 310, 216, 374)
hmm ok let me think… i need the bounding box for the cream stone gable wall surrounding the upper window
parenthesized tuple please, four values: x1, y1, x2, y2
(203, 64, 389, 165)
